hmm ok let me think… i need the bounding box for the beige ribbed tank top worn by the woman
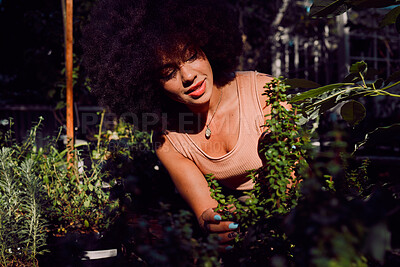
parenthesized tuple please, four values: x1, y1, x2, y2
(165, 71, 265, 190)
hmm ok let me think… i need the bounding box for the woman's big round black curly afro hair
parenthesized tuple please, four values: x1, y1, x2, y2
(81, 0, 242, 131)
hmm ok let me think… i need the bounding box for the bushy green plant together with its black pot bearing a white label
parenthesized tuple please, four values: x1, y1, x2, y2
(39, 114, 120, 266)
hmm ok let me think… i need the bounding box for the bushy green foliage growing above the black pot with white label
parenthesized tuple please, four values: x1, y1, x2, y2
(40, 116, 119, 234)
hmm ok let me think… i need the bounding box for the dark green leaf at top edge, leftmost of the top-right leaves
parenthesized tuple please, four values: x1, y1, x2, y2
(310, 0, 348, 17)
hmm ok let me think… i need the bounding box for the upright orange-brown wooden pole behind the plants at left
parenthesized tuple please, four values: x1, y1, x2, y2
(63, 0, 75, 166)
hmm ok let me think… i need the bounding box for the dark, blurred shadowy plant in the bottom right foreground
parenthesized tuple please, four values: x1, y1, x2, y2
(285, 129, 399, 266)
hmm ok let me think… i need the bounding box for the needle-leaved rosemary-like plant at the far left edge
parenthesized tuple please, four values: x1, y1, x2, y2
(0, 118, 48, 266)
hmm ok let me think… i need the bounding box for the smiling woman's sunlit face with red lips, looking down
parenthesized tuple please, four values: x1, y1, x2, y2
(160, 46, 214, 108)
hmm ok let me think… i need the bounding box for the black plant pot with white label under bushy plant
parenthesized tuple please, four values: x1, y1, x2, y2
(39, 233, 121, 267)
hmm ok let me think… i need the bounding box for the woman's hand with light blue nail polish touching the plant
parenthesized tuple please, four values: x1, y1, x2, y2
(199, 208, 239, 250)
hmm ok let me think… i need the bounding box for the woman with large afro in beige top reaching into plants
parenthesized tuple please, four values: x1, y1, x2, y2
(83, 0, 282, 248)
